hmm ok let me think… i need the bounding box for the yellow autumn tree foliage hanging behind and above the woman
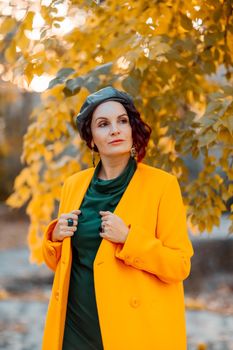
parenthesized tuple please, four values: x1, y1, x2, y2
(0, 0, 233, 262)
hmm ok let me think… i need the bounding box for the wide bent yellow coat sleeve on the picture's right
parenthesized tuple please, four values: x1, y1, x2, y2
(115, 175, 194, 283)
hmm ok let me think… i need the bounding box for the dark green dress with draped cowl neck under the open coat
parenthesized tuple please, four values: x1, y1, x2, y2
(62, 157, 137, 350)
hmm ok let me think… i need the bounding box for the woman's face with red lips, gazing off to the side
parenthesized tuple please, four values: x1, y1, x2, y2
(91, 101, 133, 157)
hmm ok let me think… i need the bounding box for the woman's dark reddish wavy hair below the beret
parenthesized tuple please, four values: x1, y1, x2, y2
(78, 102, 152, 162)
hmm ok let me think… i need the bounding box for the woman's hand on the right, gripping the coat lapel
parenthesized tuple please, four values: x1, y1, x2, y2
(99, 210, 129, 243)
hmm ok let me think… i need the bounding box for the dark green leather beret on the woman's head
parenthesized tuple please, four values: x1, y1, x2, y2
(76, 86, 134, 137)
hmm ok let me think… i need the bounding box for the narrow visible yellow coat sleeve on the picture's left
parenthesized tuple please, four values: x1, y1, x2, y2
(42, 182, 67, 271)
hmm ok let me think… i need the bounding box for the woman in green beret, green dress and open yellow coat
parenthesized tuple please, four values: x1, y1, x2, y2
(42, 86, 193, 350)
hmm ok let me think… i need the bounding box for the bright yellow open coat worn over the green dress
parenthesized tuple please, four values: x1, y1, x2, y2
(42, 163, 193, 350)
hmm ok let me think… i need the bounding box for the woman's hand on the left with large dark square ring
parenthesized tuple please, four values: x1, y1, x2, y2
(51, 210, 81, 242)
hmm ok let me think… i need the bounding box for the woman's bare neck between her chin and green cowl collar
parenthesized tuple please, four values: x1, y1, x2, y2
(98, 154, 130, 180)
